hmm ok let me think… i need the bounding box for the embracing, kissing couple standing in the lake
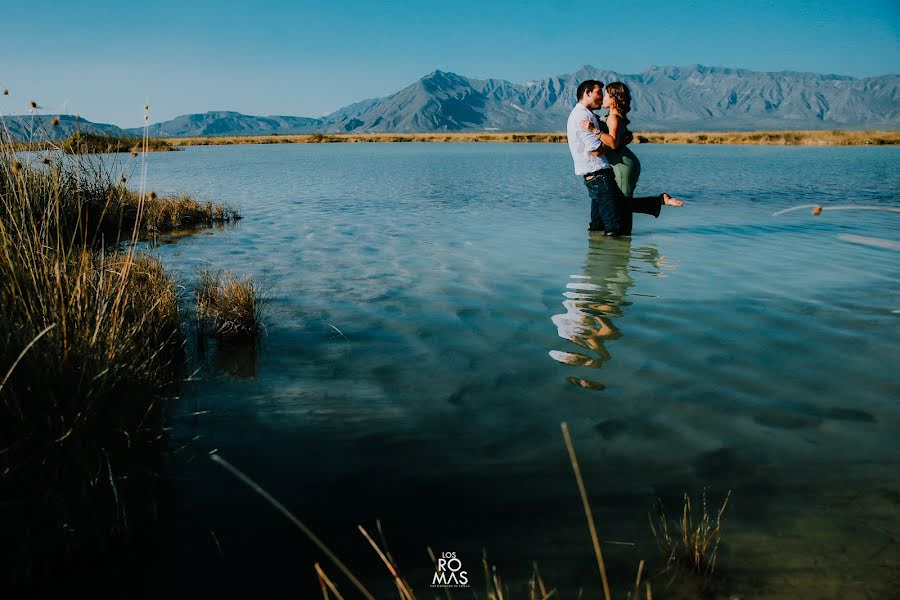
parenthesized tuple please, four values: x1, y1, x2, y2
(566, 79, 684, 237)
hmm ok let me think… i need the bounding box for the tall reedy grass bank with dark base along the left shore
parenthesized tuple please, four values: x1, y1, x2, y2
(0, 135, 232, 584)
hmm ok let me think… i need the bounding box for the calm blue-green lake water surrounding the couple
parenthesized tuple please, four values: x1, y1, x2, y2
(98, 144, 900, 598)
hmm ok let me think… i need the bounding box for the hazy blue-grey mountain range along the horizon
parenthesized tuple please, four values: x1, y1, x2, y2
(5, 65, 900, 139)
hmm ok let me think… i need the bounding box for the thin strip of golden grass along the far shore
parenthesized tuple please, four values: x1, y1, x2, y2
(164, 130, 900, 146)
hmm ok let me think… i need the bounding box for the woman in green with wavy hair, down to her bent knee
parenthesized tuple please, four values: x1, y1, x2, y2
(581, 81, 641, 198)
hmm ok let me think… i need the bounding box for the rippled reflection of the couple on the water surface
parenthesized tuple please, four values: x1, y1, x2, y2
(550, 234, 663, 390)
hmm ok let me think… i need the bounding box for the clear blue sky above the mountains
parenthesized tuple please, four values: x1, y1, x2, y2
(0, 0, 900, 127)
